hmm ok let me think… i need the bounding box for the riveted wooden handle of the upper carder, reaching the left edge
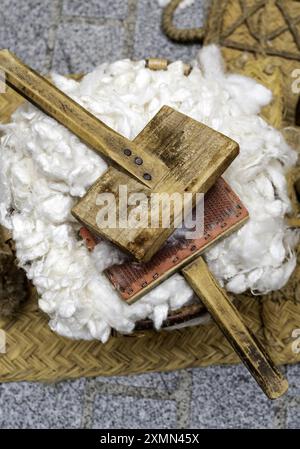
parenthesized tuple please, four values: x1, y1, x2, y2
(0, 50, 167, 188)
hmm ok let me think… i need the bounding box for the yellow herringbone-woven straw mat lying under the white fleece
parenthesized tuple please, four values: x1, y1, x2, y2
(0, 54, 300, 382)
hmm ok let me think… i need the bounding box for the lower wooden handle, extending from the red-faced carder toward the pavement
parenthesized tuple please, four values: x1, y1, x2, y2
(182, 257, 288, 399)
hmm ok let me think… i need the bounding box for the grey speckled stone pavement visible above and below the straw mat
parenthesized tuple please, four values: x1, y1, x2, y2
(0, 0, 300, 429)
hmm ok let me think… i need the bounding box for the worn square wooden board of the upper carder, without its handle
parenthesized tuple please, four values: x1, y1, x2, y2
(72, 106, 239, 261)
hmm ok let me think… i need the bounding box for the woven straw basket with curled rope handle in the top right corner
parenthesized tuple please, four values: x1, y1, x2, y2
(162, 0, 300, 124)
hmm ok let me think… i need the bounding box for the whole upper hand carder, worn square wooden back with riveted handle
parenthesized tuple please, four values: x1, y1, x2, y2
(0, 50, 239, 260)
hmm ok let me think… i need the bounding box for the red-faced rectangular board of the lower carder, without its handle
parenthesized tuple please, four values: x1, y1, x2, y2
(105, 178, 248, 304)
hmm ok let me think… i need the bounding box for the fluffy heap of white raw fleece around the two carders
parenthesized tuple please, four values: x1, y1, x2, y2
(0, 46, 298, 342)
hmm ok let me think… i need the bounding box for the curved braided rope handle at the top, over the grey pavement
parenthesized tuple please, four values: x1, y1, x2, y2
(162, 0, 205, 43)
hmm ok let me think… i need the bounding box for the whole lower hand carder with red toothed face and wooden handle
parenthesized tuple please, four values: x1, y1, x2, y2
(105, 178, 288, 399)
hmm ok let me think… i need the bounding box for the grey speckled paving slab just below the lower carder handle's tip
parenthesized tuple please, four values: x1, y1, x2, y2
(191, 365, 275, 429)
